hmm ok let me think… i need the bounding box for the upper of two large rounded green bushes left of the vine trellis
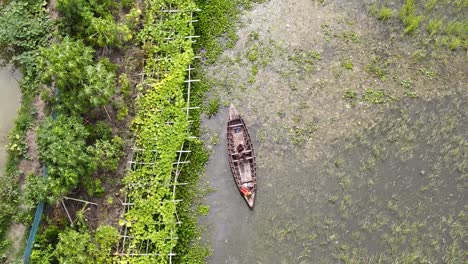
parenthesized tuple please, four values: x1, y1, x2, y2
(38, 37, 116, 114)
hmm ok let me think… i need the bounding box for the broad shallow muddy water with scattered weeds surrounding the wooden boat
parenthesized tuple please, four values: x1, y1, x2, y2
(201, 0, 468, 264)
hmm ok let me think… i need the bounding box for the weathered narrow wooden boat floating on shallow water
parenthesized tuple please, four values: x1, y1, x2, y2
(227, 104, 257, 209)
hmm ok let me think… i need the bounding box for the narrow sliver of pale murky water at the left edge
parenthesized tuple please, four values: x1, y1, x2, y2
(0, 65, 21, 175)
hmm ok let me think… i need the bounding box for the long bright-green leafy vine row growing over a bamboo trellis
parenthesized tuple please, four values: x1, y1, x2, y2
(117, 0, 201, 263)
